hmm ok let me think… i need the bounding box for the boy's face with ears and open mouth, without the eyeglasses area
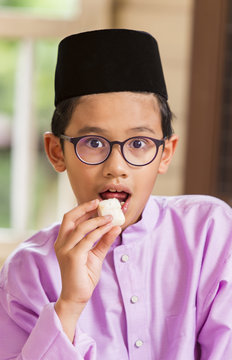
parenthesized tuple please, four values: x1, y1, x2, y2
(45, 92, 177, 228)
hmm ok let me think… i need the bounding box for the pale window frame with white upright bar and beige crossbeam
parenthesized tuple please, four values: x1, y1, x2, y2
(0, 0, 112, 250)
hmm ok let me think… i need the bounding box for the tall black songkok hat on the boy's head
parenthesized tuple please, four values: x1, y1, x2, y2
(55, 29, 168, 105)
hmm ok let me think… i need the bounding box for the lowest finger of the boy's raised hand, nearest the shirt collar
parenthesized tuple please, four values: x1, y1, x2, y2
(92, 226, 122, 261)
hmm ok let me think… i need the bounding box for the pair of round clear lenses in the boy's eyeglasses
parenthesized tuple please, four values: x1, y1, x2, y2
(76, 136, 157, 165)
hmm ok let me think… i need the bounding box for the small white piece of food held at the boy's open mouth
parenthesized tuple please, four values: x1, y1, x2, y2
(98, 198, 125, 226)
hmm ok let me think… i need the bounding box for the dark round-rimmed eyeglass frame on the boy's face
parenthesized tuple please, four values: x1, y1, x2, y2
(59, 134, 167, 166)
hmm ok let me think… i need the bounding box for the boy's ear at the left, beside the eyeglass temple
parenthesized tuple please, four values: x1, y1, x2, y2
(44, 132, 66, 172)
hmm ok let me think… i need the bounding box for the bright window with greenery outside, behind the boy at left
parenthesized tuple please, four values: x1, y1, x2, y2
(0, 0, 110, 236)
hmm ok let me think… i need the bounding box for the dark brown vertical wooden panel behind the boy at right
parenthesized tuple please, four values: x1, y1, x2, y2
(185, 0, 227, 195)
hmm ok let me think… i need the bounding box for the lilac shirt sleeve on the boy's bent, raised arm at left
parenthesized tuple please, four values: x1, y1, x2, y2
(0, 229, 96, 360)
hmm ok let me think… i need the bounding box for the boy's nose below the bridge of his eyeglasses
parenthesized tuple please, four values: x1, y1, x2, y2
(103, 145, 129, 178)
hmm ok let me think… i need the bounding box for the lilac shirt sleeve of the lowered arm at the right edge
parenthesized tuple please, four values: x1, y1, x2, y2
(197, 201, 232, 360)
